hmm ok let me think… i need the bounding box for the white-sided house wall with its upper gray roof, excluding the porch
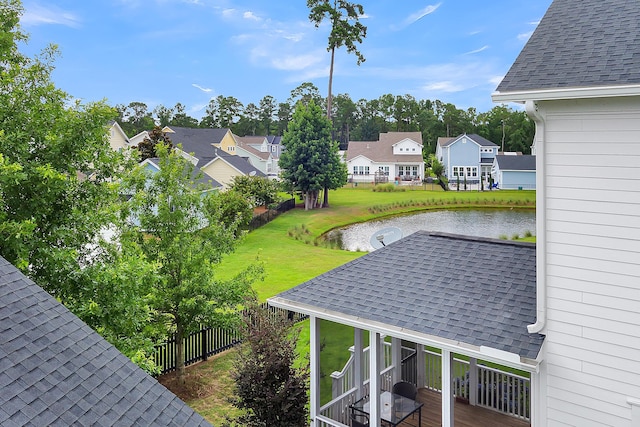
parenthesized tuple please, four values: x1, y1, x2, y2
(492, 0, 640, 427)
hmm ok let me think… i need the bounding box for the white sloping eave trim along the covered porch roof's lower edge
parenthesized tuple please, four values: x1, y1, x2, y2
(267, 296, 540, 373)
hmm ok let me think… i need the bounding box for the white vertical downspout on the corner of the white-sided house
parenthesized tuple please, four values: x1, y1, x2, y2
(525, 101, 547, 334)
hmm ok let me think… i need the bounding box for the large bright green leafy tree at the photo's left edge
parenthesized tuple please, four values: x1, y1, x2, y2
(0, 0, 130, 302)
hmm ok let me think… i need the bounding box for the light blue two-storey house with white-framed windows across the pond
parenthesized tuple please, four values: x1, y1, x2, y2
(436, 134, 498, 185)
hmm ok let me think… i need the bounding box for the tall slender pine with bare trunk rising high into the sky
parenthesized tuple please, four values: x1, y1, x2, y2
(307, 0, 367, 118)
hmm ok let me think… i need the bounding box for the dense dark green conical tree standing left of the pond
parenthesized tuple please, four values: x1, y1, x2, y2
(280, 101, 347, 210)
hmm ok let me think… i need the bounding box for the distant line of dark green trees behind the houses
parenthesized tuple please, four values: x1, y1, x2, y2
(115, 82, 535, 156)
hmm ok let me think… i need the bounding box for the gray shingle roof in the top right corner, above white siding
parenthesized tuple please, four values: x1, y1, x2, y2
(497, 0, 640, 92)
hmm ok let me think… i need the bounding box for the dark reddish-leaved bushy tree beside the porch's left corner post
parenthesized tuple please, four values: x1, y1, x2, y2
(232, 302, 309, 427)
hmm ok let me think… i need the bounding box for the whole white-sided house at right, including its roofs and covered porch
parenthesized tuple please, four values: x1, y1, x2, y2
(269, 0, 640, 427)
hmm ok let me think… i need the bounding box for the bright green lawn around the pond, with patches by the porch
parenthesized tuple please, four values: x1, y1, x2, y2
(187, 185, 535, 423)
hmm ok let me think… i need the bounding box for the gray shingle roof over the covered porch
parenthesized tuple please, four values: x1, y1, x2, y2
(277, 231, 543, 359)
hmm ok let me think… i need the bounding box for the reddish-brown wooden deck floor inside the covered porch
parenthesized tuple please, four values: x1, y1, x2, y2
(400, 389, 531, 427)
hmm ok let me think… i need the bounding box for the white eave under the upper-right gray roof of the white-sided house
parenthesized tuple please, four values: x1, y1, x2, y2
(491, 84, 640, 103)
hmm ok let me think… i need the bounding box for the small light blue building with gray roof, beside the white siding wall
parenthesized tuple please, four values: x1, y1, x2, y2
(491, 154, 536, 190)
